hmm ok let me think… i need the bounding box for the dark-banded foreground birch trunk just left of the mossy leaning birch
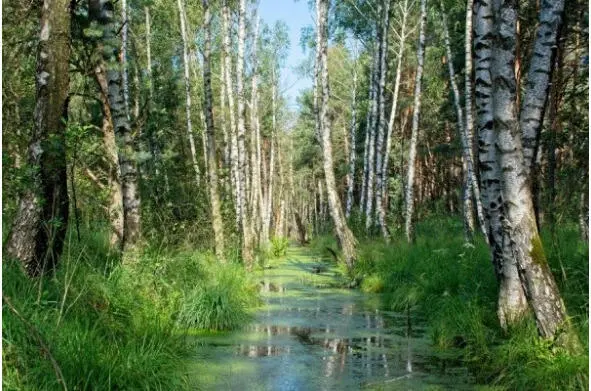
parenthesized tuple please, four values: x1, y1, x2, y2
(474, 0, 527, 329)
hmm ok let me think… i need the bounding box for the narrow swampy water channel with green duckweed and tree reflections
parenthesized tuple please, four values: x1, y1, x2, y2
(194, 248, 472, 391)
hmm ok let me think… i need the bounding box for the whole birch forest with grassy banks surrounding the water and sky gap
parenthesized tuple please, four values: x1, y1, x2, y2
(2, 0, 589, 389)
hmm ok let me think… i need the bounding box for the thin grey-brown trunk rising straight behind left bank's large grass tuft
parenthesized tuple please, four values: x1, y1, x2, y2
(203, 0, 225, 262)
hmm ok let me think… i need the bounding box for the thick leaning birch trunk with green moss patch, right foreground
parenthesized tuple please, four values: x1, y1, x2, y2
(491, 2, 581, 351)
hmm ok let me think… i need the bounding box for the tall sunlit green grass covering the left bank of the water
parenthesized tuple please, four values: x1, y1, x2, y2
(2, 228, 258, 390)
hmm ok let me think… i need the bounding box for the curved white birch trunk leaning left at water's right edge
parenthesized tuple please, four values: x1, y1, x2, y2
(316, 0, 357, 269)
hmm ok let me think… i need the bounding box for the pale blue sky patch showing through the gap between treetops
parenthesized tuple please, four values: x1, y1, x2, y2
(259, 0, 314, 109)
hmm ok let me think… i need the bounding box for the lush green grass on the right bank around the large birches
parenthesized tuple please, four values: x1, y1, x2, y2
(312, 219, 589, 390)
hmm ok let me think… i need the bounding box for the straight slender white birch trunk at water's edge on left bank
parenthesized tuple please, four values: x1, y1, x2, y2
(236, 0, 254, 269)
